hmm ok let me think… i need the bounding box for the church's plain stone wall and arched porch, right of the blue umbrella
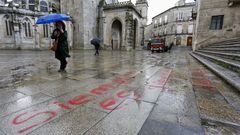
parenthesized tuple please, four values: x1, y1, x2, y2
(61, 0, 148, 50)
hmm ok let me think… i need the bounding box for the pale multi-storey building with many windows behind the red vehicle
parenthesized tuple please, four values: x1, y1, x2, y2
(146, 0, 195, 46)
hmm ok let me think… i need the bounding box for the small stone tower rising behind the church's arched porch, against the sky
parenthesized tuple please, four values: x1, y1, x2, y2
(136, 0, 148, 25)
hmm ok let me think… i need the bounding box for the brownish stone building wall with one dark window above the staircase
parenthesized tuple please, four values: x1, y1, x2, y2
(193, 0, 240, 50)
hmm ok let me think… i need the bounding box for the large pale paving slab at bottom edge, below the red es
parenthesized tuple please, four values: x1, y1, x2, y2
(86, 99, 153, 135)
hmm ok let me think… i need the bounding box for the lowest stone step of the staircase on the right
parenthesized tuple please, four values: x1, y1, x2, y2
(190, 52, 240, 91)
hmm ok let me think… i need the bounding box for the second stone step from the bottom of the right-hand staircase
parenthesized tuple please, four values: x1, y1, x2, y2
(194, 51, 240, 75)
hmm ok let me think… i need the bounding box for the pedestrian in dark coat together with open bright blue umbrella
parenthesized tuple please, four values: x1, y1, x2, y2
(37, 14, 70, 72)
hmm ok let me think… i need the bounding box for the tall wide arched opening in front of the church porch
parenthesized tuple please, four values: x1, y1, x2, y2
(111, 20, 122, 50)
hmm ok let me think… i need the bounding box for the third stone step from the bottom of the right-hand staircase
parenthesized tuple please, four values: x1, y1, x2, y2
(197, 49, 240, 62)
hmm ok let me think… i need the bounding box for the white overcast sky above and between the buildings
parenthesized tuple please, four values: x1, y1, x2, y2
(119, 0, 194, 23)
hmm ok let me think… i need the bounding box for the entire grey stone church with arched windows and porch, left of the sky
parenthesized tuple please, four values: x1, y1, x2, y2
(0, 0, 148, 50)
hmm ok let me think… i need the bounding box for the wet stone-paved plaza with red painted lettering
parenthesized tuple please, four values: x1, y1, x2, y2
(0, 47, 240, 135)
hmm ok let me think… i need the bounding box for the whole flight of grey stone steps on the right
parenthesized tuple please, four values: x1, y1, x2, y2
(190, 38, 240, 91)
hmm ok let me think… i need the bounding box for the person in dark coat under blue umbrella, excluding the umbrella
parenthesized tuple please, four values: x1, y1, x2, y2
(51, 21, 70, 72)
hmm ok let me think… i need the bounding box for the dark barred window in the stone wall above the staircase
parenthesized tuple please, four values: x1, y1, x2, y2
(210, 15, 224, 30)
